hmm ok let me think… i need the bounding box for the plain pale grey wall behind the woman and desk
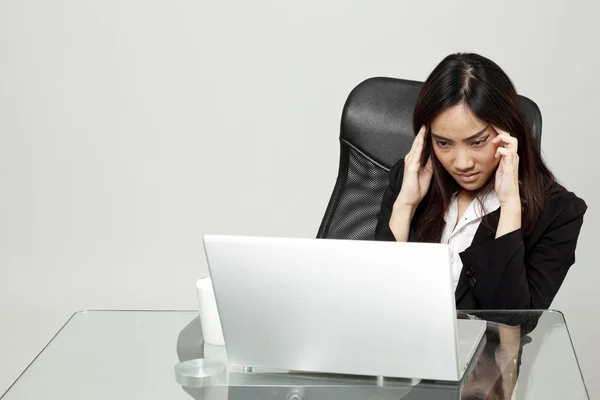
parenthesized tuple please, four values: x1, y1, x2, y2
(0, 0, 600, 397)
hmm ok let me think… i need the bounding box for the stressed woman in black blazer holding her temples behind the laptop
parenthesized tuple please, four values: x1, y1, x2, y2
(376, 54, 587, 310)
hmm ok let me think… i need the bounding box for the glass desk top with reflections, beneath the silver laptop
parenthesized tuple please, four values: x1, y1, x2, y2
(2, 311, 589, 400)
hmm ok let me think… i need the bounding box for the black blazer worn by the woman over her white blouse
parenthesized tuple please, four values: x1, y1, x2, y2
(375, 160, 587, 310)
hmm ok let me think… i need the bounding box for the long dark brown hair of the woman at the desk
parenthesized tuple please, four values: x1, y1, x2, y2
(413, 53, 556, 242)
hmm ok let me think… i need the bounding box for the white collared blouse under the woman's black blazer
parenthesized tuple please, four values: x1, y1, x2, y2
(441, 189, 500, 290)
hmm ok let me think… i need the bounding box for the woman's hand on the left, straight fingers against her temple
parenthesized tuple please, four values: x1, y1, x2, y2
(394, 126, 433, 211)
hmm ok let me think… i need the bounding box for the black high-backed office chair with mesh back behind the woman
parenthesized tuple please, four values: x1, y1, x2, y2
(317, 78, 542, 240)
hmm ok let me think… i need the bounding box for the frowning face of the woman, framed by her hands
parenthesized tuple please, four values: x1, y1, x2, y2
(430, 104, 500, 191)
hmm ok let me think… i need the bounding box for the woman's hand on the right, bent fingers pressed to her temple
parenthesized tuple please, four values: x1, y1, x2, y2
(492, 126, 521, 209)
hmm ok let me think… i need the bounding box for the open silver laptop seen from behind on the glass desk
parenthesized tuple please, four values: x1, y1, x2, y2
(203, 235, 485, 381)
